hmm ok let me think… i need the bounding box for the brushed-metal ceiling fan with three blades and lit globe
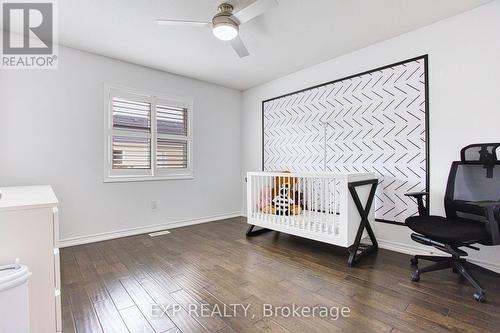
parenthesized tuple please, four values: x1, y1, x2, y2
(156, 0, 278, 58)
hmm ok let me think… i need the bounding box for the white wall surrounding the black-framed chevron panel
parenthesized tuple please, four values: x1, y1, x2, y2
(241, 1, 500, 270)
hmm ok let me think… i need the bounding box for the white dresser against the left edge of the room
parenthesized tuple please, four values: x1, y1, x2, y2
(0, 186, 61, 333)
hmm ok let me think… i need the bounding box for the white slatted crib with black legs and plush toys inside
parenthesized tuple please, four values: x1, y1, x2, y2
(247, 172, 378, 266)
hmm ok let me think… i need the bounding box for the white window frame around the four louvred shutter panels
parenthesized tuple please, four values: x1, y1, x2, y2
(103, 83, 194, 183)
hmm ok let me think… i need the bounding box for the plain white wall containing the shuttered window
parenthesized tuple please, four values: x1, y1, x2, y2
(0, 48, 242, 243)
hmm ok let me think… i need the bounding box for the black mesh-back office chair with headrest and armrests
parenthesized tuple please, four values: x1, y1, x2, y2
(405, 143, 500, 302)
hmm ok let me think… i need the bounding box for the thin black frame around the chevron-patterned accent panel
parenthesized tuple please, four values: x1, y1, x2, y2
(261, 54, 430, 226)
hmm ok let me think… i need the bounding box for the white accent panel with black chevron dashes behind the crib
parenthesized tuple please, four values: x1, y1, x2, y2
(262, 56, 428, 223)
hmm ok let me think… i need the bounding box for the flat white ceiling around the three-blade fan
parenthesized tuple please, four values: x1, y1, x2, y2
(58, 0, 490, 90)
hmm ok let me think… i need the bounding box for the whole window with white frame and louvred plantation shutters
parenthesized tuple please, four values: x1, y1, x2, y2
(105, 84, 193, 181)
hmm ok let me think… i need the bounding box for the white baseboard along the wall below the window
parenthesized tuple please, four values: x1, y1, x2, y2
(59, 212, 241, 248)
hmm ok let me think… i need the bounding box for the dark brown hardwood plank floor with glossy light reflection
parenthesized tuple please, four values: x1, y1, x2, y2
(61, 218, 500, 333)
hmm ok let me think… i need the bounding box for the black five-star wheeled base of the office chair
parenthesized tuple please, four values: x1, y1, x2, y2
(410, 255, 486, 303)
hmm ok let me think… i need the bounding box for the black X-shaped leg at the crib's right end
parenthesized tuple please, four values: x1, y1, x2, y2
(347, 179, 378, 267)
